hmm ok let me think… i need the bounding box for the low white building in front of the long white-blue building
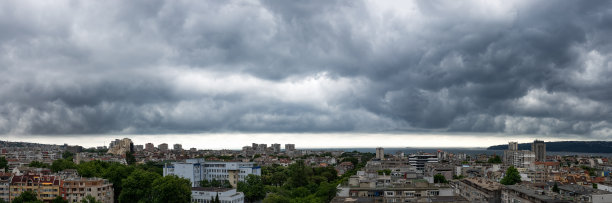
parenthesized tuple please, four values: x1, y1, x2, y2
(191, 187, 244, 203)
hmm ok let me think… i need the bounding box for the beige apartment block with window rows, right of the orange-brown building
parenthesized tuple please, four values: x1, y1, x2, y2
(62, 178, 114, 203)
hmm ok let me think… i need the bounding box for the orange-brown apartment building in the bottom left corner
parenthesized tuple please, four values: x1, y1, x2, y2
(10, 175, 62, 202)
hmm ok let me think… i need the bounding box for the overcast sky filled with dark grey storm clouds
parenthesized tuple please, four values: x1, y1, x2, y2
(0, 0, 612, 147)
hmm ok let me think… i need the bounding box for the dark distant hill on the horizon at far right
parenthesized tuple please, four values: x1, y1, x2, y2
(487, 141, 612, 153)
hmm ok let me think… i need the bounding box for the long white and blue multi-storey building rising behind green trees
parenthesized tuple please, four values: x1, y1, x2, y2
(164, 159, 261, 187)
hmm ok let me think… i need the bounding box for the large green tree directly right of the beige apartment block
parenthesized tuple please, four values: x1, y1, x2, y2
(119, 169, 161, 202)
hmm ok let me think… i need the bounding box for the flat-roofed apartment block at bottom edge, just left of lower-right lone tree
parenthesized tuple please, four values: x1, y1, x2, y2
(451, 178, 502, 203)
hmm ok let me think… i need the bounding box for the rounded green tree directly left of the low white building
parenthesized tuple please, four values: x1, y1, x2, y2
(153, 175, 191, 203)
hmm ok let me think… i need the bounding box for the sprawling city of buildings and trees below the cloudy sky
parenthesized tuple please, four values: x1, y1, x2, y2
(0, 138, 612, 203)
